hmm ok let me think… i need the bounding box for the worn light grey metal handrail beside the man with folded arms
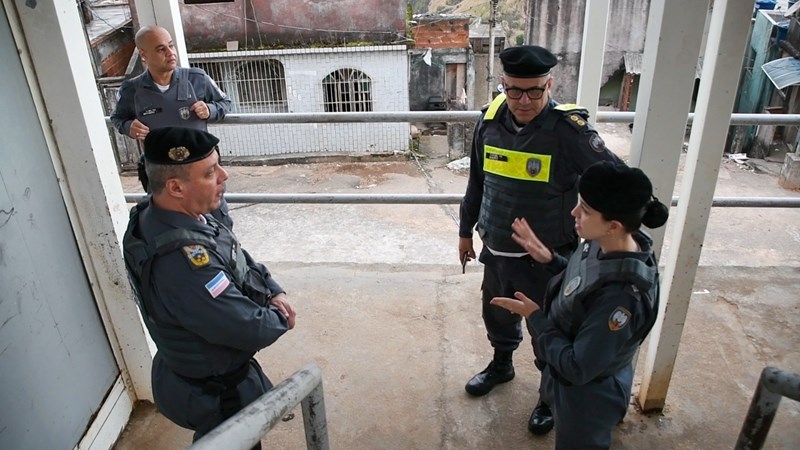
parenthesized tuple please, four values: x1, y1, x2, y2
(189, 364, 330, 450)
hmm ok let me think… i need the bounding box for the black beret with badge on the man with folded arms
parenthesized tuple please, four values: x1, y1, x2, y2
(144, 127, 219, 164)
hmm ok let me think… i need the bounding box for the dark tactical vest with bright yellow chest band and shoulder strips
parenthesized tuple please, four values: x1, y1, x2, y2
(478, 95, 586, 252)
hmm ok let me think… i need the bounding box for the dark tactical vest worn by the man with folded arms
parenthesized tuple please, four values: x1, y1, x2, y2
(123, 200, 253, 378)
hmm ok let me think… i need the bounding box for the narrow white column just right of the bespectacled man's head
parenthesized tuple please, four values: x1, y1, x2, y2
(577, 0, 611, 121)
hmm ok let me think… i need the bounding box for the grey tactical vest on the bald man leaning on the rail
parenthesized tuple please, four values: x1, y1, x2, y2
(133, 68, 207, 131)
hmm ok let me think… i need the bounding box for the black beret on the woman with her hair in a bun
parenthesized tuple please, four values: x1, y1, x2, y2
(578, 161, 653, 215)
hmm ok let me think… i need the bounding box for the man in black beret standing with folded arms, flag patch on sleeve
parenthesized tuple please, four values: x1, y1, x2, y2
(123, 127, 295, 448)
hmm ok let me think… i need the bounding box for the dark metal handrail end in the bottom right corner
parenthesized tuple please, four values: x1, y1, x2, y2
(734, 367, 800, 450)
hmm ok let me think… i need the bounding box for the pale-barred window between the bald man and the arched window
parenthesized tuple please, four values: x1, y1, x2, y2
(235, 59, 289, 113)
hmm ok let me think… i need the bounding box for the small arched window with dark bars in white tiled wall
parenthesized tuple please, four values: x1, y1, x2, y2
(322, 69, 372, 112)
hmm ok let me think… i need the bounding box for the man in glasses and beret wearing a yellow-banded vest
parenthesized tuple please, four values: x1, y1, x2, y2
(458, 45, 621, 435)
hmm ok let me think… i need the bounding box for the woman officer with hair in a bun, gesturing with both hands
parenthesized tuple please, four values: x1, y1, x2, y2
(492, 162, 669, 450)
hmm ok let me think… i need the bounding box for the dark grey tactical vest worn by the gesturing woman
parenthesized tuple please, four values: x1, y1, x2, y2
(545, 237, 659, 376)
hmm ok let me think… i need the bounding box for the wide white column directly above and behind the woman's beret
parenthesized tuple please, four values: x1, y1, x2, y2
(629, 0, 709, 254)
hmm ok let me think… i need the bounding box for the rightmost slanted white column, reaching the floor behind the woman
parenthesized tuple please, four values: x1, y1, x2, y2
(639, 0, 753, 411)
